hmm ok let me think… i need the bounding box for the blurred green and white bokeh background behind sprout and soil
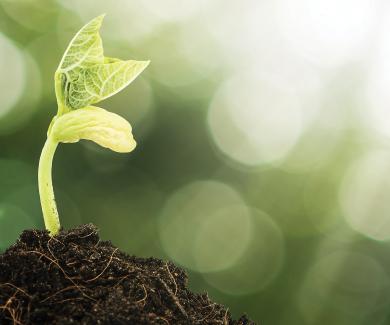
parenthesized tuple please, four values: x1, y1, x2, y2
(0, 0, 390, 325)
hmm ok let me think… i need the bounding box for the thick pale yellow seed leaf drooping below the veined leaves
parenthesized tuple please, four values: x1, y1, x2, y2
(50, 106, 136, 152)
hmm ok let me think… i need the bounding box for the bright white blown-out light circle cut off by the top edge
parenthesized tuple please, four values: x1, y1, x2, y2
(277, 0, 376, 67)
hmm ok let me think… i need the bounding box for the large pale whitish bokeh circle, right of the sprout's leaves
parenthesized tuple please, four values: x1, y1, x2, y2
(208, 74, 303, 166)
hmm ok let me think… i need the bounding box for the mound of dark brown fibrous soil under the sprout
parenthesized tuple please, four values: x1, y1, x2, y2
(0, 225, 254, 325)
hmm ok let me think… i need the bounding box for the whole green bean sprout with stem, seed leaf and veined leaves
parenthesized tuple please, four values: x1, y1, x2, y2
(38, 15, 149, 236)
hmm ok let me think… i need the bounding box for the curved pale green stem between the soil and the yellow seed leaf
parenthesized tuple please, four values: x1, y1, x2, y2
(38, 135, 60, 236)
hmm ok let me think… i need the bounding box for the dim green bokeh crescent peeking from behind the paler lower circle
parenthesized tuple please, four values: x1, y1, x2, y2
(202, 209, 285, 295)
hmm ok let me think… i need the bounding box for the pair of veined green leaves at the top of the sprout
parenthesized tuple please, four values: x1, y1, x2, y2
(55, 15, 149, 111)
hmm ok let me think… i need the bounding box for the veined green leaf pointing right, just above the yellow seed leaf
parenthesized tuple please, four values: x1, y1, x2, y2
(65, 59, 149, 109)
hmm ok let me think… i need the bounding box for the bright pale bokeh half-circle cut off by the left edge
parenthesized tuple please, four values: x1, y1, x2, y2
(0, 33, 26, 119)
